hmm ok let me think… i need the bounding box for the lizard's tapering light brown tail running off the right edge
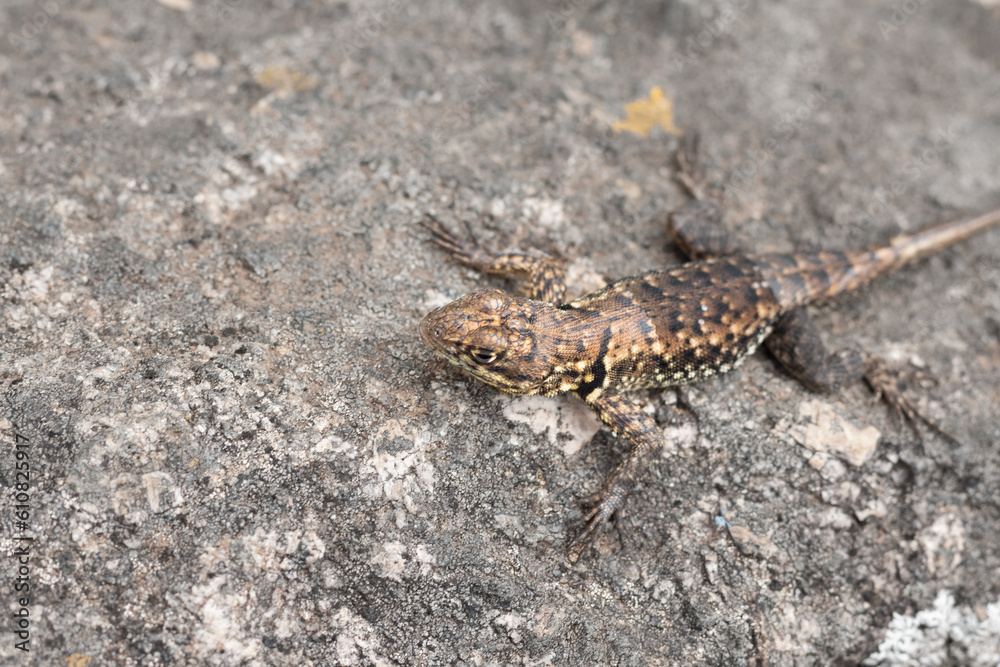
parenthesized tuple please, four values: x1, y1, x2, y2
(760, 209, 1000, 308)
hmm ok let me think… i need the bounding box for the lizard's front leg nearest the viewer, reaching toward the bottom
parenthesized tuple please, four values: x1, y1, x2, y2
(570, 389, 663, 549)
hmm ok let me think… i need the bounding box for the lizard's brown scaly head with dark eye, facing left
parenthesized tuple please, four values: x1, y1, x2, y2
(420, 289, 559, 395)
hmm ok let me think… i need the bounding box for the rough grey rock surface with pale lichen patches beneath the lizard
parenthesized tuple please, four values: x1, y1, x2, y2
(0, 0, 1000, 667)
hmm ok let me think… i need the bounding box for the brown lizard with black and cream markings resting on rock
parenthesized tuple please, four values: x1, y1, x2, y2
(419, 147, 1000, 549)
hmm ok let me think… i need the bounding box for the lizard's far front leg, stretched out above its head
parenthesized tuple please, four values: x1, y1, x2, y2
(421, 214, 566, 306)
